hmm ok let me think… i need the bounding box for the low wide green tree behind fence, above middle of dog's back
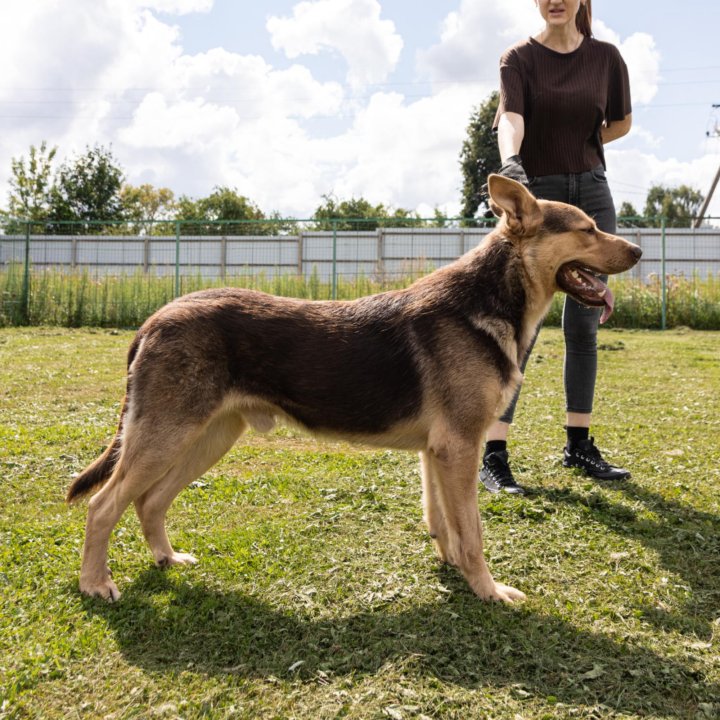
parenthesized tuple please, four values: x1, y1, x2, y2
(312, 195, 419, 230)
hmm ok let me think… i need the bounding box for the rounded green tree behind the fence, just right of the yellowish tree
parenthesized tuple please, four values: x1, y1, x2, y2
(175, 187, 280, 235)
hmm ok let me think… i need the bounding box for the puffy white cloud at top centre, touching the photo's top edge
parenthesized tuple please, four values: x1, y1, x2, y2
(267, 0, 403, 87)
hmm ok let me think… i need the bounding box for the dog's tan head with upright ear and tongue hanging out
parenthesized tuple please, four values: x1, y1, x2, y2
(488, 175, 642, 322)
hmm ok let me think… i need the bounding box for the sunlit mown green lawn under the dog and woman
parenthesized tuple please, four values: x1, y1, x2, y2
(0, 328, 720, 720)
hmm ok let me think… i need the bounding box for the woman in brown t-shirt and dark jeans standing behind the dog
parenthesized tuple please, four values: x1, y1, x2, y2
(480, 0, 632, 494)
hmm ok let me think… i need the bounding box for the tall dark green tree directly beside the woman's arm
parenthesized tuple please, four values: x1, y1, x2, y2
(460, 92, 500, 225)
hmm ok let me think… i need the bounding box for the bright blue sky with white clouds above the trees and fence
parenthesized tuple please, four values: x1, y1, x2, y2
(0, 0, 720, 218)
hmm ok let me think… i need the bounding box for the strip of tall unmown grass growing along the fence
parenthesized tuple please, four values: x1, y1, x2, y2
(0, 264, 720, 330)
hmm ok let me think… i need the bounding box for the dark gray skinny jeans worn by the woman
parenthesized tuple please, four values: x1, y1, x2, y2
(500, 165, 616, 423)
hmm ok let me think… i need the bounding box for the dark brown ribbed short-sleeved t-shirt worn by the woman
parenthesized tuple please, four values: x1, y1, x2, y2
(495, 37, 631, 177)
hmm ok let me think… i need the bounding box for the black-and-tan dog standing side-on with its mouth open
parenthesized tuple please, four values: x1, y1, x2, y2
(67, 175, 642, 603)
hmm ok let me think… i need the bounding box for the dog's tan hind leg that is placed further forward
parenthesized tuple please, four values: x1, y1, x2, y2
(135, 413, 247, 567)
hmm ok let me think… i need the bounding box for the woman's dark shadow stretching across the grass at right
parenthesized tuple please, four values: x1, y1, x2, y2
(536, 482, 720, 640)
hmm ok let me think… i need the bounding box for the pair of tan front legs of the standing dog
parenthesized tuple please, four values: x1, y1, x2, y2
(423, 436, 525, 603)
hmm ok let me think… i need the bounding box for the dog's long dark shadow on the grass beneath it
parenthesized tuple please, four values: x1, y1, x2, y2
(84, 568, 720, 718)
